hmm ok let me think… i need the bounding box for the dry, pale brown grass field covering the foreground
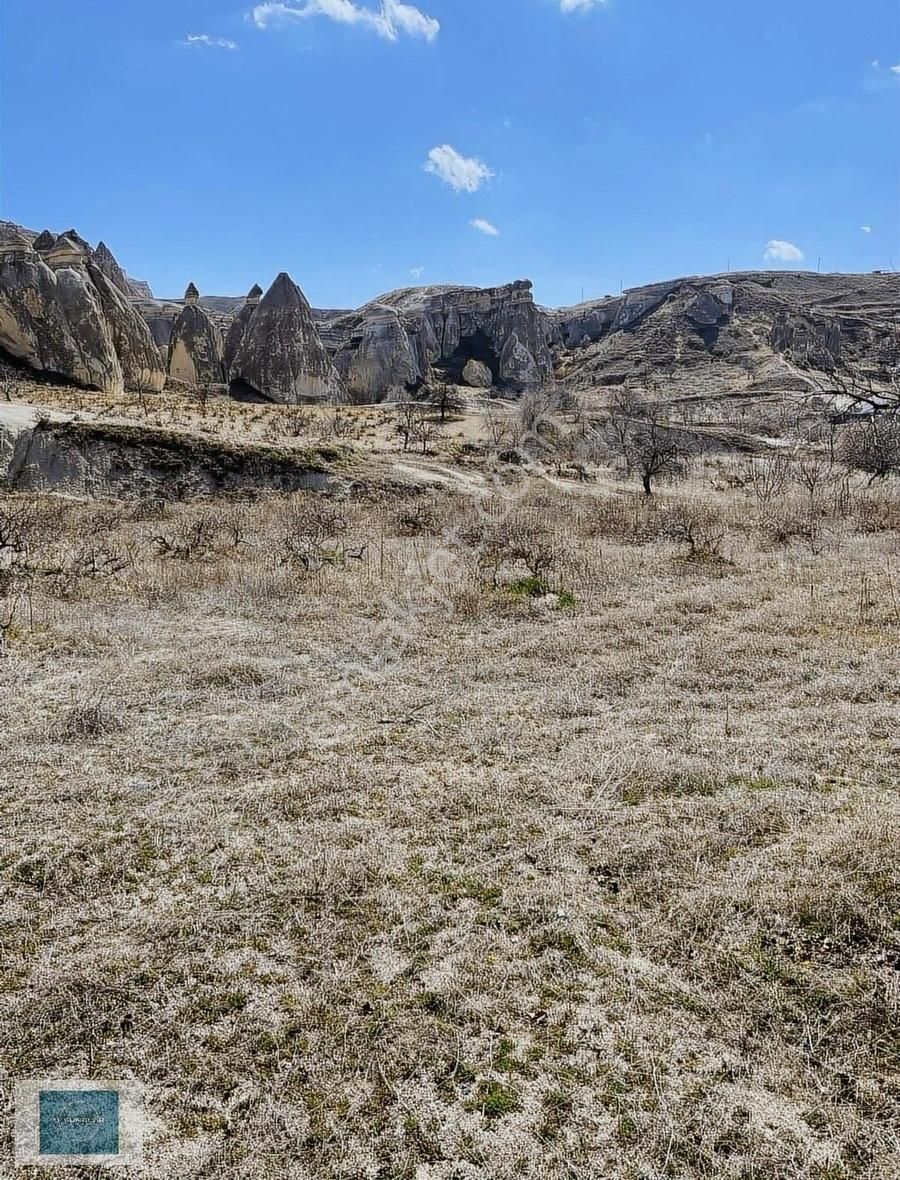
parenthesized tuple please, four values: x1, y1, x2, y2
(0, 401, 900, 1180)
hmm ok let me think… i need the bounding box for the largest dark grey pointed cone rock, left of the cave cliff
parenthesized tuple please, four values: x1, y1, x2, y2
(229, 273, 343, 404)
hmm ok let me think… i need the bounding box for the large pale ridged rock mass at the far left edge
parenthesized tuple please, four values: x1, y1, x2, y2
(0, 235, 165, 393)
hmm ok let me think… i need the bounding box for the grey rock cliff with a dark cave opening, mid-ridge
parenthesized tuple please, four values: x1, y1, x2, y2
(321, 281, 552, 401)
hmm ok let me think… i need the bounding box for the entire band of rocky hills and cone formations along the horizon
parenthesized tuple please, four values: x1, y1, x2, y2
(0, 222, 900, 402)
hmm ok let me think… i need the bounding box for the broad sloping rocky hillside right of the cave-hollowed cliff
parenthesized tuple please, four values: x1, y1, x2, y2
(547, 271, 900, 396)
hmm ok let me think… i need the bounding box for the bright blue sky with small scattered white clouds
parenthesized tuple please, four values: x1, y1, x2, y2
(0, 0, 900, 307)
